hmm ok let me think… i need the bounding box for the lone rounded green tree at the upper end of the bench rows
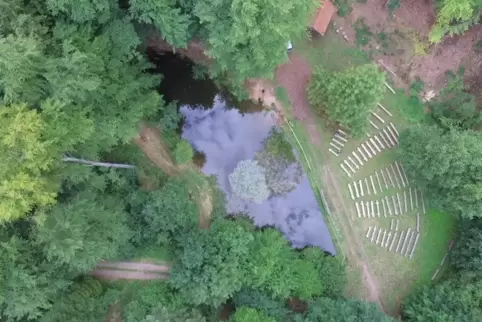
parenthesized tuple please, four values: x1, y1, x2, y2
(308, 64, 385, 135)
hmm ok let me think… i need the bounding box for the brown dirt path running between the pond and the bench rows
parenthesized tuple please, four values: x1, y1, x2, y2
(276, 54, 383, 309)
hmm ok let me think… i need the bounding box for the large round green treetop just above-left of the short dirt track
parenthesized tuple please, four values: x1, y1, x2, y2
(36, 192, 130, 273)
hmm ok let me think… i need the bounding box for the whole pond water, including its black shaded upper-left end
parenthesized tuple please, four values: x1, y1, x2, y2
(158, 51, 336, 254)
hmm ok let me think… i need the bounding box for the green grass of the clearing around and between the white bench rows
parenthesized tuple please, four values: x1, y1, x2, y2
(282, 26, 455, 313)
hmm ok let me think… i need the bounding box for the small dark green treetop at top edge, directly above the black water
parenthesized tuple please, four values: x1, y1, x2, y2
(129, 0, 190, 48)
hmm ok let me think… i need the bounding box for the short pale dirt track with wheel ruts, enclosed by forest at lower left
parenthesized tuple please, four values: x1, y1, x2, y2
(90, 262, 169, 280)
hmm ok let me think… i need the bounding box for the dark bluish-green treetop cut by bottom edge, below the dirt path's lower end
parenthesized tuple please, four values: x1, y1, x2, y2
(295, 298, 394, 322)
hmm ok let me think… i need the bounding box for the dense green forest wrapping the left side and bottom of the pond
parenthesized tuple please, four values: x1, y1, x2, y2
(0, 0, 391, 322)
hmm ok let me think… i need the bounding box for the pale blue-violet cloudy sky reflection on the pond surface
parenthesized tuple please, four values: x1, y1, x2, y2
(181, 95, 335, 254)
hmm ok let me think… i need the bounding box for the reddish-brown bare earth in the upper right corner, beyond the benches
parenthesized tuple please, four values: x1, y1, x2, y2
(334, 0, 482, 92)
